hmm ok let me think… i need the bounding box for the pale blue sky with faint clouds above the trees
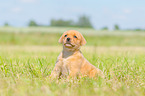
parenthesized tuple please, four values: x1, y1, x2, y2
(0, 0, 145, 29)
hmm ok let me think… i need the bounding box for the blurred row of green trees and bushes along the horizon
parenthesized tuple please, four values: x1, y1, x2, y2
(4, 15, 144, 31)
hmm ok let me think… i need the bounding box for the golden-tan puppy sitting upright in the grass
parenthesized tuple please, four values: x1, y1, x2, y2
(50, 30, 104, 78)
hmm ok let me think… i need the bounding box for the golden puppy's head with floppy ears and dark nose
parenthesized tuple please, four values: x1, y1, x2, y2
(59, 30, 86, 49)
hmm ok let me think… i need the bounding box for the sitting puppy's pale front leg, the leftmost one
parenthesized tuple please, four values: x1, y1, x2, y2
(49, 61, 62, 79)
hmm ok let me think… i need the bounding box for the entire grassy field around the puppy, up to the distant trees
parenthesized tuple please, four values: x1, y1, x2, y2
(0, 28, 145, 96)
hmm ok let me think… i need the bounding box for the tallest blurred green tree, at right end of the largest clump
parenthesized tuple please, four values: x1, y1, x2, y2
(76, 15, 93, 28)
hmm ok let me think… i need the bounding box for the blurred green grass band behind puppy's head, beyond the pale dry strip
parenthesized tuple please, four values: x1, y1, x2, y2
(0, 29, 145, 46)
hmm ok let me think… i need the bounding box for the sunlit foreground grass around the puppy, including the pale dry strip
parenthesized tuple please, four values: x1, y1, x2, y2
(0, 45, 145, 96)
